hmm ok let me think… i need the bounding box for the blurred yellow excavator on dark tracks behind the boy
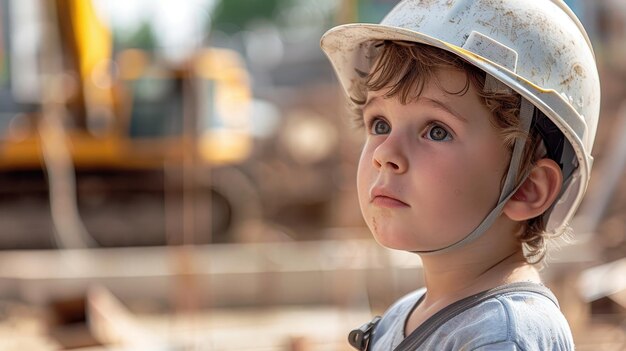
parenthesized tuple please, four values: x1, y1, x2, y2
(0, 0, 252, 249)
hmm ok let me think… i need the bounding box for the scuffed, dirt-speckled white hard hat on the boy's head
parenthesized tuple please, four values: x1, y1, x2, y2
(321, 0, 600, 253)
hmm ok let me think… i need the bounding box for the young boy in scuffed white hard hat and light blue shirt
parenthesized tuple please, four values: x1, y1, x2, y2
(321, 0, 600, 350)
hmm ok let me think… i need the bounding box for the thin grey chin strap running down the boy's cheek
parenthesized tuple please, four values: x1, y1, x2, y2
(413, 97, 535, 255)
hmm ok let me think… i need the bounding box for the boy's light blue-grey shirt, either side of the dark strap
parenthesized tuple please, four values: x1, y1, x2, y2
(372, 288, 574, 350)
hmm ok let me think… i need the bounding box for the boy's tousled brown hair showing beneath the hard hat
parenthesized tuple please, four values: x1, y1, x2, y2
(351, 41, 553, 264)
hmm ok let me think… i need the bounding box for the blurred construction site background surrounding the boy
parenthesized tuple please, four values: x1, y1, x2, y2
(0, 0, 626, 351)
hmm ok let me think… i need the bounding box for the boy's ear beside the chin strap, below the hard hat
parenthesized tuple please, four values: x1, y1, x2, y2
(502, 158, 563, 222)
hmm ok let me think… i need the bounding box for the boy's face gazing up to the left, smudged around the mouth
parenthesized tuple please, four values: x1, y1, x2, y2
(357, 70, 510, 251)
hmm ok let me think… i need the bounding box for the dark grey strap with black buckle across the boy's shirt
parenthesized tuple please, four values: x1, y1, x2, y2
(348, 282, 558, 351)
